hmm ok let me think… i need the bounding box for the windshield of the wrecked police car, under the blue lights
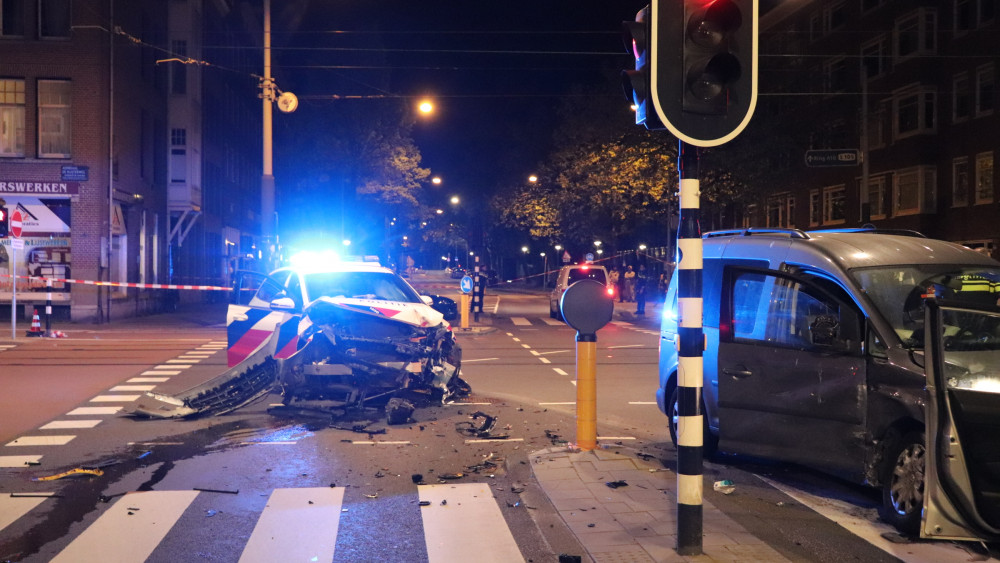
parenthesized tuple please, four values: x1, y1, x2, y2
(304, 271, 422, 303)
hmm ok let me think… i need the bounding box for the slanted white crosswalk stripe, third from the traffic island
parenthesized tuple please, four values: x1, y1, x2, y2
(52, 491, 198, 563)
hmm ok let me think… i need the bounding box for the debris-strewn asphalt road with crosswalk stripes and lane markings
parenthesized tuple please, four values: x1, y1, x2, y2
(0, 281, 985, 561)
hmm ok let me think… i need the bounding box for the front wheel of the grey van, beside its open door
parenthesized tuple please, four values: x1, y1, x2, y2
(881, 432, 927, 536)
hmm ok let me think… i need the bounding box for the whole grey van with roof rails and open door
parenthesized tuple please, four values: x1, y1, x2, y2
(656, 229, 1000, 539)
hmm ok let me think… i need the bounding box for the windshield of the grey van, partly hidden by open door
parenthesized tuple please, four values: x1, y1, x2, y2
(851, 264, 1000, 348)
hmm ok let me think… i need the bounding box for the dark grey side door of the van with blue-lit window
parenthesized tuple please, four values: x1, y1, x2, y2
(718, 267, 866, 472)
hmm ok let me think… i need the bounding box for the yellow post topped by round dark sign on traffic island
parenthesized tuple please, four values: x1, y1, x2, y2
(560, 279, 615, 451)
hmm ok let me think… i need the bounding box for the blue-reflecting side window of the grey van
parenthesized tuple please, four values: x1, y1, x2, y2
(732, 272, 840, 350)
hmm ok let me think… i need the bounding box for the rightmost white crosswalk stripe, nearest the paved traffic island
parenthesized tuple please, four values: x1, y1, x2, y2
(417, 483, 524, 563)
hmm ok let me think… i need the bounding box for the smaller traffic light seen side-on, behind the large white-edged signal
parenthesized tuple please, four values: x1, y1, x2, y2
(622, 6, 664, 129)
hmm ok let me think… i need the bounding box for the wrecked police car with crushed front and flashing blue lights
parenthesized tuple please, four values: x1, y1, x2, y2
(130, 255, 470, 418)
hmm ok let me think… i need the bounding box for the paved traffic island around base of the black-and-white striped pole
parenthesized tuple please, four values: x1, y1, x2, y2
(530, 446, 788, 563)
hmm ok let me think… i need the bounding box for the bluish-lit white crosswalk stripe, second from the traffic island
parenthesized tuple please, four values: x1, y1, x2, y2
(240, 487, 344, 563)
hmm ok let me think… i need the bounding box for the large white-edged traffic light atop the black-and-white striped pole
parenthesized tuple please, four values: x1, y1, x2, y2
(651, 0, 758, 147)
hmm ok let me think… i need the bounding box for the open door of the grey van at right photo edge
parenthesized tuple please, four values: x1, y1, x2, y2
(920, 295, 1000, 541)
